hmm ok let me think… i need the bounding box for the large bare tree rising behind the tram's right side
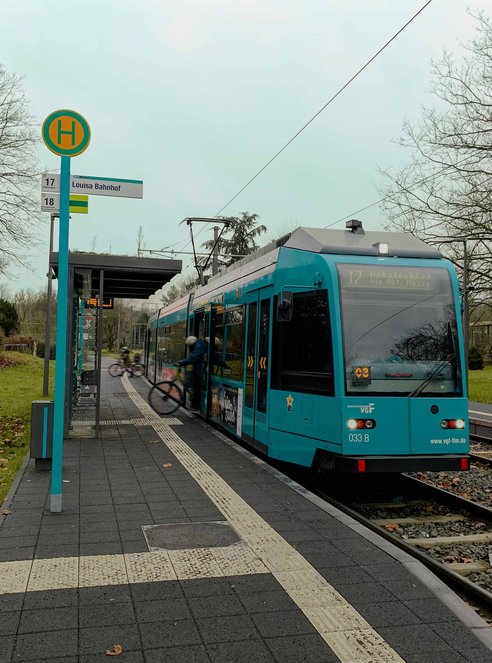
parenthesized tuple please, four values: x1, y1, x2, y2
(382, 14, 492, 303)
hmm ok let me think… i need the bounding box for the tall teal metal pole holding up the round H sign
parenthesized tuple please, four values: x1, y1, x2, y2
(50, 157, 70, 513)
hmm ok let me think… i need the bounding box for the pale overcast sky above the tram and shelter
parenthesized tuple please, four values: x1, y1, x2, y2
(0, 0, 489, 300)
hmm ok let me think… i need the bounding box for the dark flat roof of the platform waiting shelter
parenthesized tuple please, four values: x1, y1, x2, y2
(50, 253, 182, 299)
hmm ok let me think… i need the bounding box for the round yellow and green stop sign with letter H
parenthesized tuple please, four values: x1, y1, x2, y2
(42, 109, 91, 157)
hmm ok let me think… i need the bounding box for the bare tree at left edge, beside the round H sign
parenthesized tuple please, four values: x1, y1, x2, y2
(0, 65, 40, 273)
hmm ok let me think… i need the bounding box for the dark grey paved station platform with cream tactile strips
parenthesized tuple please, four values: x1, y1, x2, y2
(0, 375, 492, 663)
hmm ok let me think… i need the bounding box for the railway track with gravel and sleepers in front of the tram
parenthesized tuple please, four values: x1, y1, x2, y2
(316, 468, 492, 620)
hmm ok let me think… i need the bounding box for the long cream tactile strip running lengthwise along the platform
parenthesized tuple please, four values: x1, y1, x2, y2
(122, 379, 403, 663)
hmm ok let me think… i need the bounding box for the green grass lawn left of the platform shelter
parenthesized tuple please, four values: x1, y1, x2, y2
(0, 352, 55, 505)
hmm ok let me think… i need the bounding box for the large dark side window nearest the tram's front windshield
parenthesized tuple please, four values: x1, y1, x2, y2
(271, 290, 334, 396)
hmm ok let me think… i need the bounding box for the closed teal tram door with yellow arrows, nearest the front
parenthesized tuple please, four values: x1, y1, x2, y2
(242, 288, 273, 452)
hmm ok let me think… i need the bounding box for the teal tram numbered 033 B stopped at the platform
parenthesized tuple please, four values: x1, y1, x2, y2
(146, 226, 469, 473)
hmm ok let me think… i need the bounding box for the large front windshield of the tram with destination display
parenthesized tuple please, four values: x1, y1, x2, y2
(337, 264, 462, 397)
